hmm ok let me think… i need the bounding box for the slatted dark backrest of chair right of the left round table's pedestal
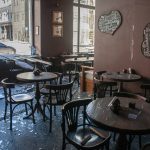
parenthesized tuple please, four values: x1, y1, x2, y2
(45, 81, 73, 105)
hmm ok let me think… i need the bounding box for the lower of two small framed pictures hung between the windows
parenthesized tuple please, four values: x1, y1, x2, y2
(53, 25, 63, 37)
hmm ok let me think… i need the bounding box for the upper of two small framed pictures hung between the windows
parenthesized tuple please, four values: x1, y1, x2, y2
(53, 11, 63, 24)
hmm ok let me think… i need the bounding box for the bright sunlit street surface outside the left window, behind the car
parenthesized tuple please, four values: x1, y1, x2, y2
(0, 40, 31, 55)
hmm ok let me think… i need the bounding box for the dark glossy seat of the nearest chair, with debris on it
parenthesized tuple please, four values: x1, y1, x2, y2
(67, 126, 109, 149)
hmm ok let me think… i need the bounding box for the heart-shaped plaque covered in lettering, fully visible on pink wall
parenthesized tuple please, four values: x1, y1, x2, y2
(98, 10, 121, 34)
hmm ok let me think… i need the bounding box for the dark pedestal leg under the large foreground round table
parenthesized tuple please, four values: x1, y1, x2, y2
(116, 134, 128, 150)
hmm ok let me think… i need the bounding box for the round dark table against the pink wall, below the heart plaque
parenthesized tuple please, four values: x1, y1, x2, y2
(102, 72, 141, 92)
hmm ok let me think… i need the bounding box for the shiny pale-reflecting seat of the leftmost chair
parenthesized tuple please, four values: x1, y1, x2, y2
(12, 94, 33, 103)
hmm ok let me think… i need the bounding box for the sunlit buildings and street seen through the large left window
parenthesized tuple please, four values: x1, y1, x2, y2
(0, 0, 32, 55)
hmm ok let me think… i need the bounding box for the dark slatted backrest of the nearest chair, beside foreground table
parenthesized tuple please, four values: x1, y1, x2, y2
(62, 98, 92, 132)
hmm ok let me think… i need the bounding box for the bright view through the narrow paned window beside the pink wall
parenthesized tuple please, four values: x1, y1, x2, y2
(73, 0, 95, 53)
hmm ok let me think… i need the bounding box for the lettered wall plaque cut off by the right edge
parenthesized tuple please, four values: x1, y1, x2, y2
(141, 23, 150, 58)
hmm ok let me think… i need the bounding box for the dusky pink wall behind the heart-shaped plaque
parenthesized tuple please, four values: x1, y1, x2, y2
(94, 0, 150, 92)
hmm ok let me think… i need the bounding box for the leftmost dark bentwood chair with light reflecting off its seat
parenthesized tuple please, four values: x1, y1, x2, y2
(1, 78, 35, 130)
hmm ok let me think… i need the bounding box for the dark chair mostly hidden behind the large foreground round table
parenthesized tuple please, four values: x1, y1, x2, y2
(113, 92, 147, 149)
